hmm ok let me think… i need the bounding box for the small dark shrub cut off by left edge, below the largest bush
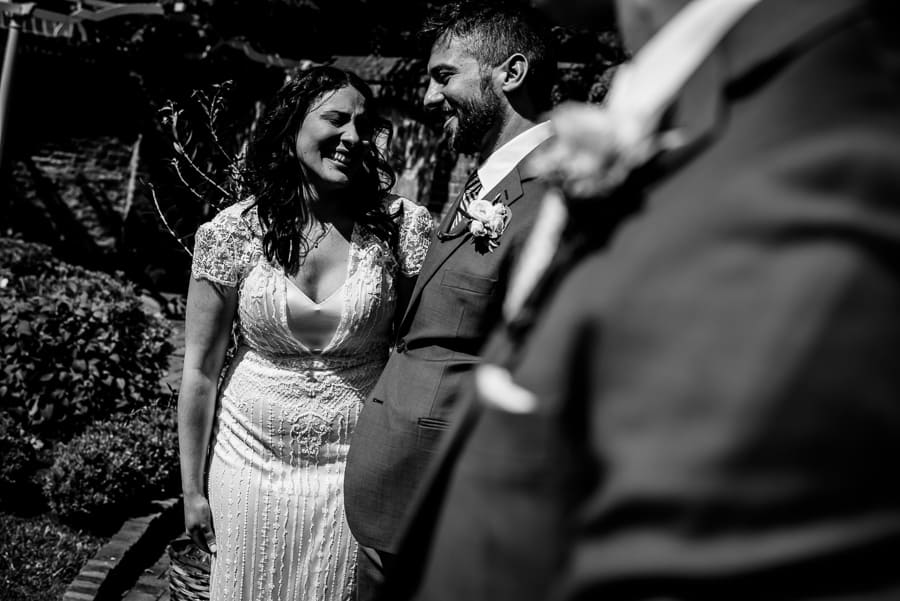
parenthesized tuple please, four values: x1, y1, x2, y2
(0, 413, 40, 509)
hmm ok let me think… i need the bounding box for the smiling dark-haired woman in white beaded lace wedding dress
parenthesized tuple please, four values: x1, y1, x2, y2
(178, 67, 432, 601)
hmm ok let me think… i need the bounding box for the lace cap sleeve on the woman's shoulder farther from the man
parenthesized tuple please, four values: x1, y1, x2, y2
(191, 202, 256, 286)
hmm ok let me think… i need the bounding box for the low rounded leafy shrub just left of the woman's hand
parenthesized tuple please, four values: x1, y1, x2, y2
(44, 403, 179, 532)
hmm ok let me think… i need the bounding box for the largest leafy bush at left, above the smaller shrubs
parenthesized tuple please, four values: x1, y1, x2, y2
(0, 238, 172, 435)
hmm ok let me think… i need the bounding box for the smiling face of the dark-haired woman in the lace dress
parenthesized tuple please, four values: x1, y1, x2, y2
(296, 86, 372, 192)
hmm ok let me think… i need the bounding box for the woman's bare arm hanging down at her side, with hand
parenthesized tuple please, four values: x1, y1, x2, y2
(178, 278, 237, 553)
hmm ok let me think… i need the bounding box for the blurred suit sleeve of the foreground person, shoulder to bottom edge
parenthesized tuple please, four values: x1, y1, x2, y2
(515, 12, 900, 601)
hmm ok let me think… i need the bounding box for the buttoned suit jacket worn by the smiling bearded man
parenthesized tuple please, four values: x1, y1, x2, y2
(345, 143, 545, 551)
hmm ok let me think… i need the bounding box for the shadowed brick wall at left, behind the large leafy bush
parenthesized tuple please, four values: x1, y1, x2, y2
(7, 136, 196, 293)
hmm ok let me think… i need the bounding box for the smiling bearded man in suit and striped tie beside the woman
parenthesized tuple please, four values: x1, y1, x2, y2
(345, 3, 556, 598)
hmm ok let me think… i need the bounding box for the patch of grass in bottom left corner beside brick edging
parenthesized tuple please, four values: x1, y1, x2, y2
(0, 514, 103, 601)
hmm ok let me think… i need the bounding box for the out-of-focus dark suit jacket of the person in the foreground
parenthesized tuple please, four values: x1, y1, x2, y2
(385, 0, 900, 601)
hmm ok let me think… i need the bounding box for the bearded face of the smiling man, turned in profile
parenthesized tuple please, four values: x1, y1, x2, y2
(423, 36, 503, 154)
